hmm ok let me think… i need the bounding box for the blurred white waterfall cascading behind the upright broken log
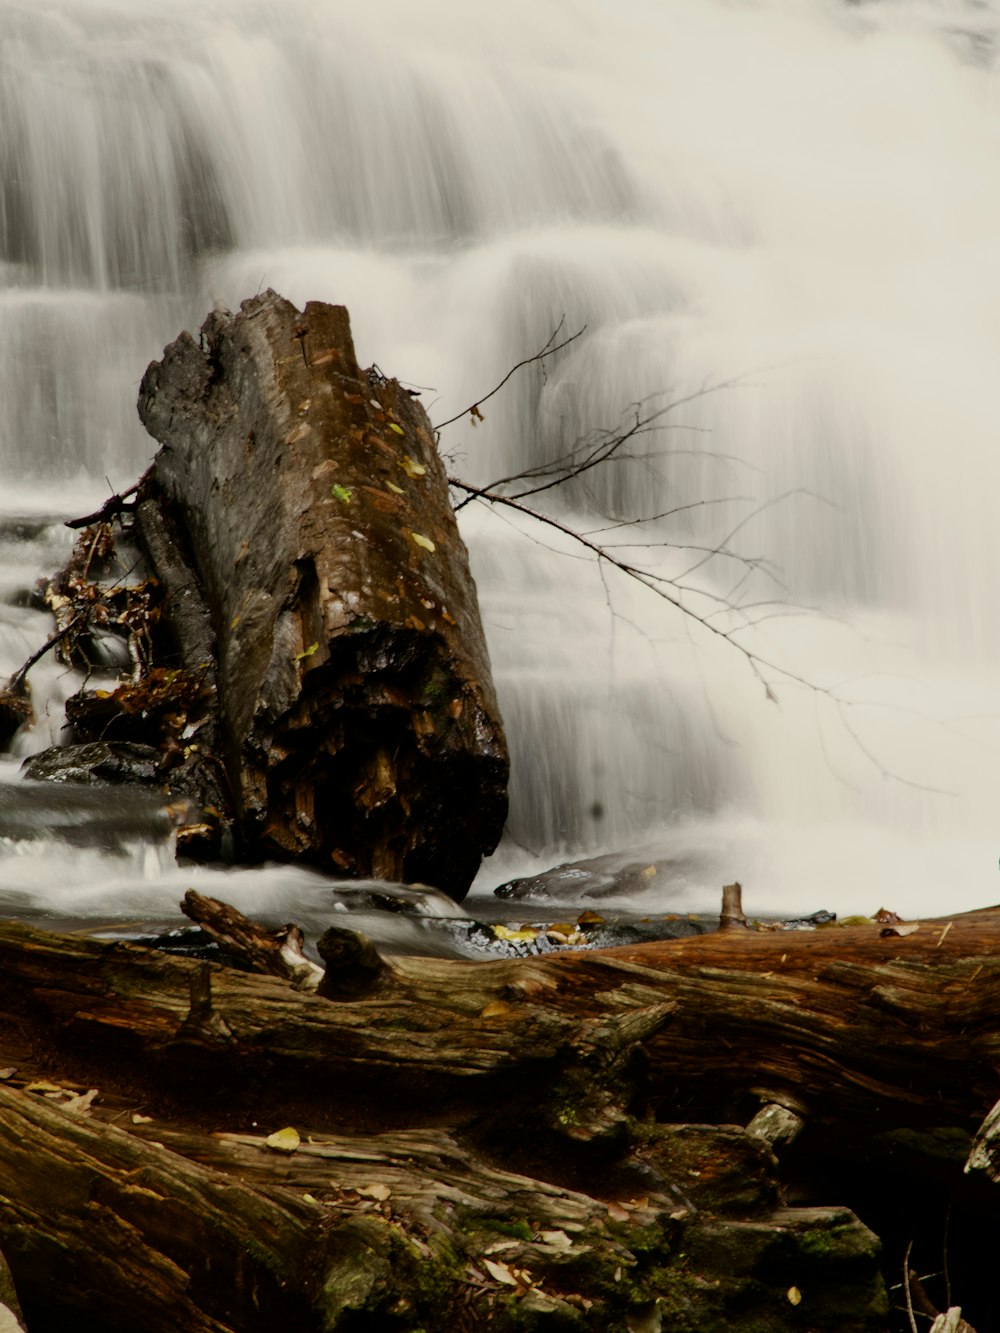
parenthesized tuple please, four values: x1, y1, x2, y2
(0, 0, 1000, 933)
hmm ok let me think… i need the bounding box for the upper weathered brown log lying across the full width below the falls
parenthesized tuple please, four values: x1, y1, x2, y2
(0, 910, 1000, 1129)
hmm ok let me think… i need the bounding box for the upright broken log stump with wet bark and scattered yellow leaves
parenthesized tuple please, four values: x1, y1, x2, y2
(136, 292, 508, 898)
